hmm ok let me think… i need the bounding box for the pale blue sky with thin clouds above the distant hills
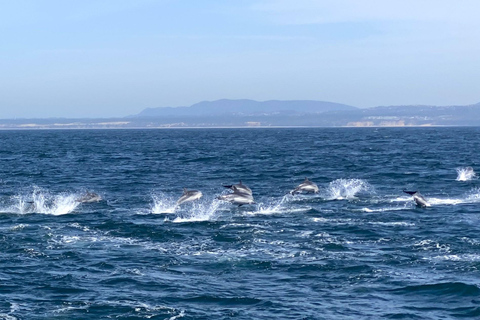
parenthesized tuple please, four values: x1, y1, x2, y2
(0, 0, 480, 119)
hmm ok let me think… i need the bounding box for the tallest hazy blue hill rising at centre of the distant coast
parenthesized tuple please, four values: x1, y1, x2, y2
(131, 99, 358, 118)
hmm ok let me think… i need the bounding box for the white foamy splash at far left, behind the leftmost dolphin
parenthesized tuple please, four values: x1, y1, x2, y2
(0, 187, 80, 216)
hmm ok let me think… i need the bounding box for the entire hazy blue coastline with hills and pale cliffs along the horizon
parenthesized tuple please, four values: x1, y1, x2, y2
(0, 99, 480, 129)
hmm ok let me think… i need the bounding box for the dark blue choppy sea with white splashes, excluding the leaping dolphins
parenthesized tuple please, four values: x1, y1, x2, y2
(0, 128, 480, 320)
